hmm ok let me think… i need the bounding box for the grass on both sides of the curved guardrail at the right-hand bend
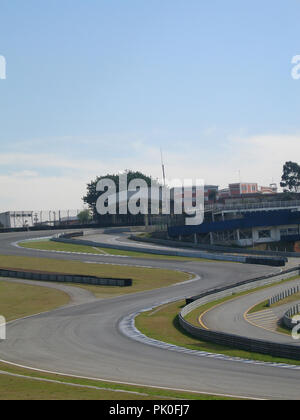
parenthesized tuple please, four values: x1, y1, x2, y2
(136, 280, 300, 365)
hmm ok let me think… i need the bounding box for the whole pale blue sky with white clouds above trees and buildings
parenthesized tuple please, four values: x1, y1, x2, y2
(0, 0, 300, 211)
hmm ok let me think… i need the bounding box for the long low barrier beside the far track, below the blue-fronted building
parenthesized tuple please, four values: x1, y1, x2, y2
(51, 236, 285, 267)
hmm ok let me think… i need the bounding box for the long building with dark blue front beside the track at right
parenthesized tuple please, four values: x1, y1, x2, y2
(169, 189, 300, 246)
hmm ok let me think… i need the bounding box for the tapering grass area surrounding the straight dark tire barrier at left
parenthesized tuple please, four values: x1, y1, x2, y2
(0, 255, 191, 298)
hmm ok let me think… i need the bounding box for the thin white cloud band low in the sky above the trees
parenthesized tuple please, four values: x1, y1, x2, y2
(0, 134, 300, 211)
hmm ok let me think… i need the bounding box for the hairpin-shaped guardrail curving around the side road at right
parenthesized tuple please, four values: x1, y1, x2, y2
(179, 269, 300, 360)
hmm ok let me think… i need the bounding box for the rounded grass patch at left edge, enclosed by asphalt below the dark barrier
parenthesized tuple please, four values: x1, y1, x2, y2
(0, 280, 70, 321)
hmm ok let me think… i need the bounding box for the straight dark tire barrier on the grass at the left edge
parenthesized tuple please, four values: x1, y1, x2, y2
(0, 268, 132, 287)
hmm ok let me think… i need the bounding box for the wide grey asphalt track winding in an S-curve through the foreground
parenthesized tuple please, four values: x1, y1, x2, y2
(0, 231, 300, 399)
